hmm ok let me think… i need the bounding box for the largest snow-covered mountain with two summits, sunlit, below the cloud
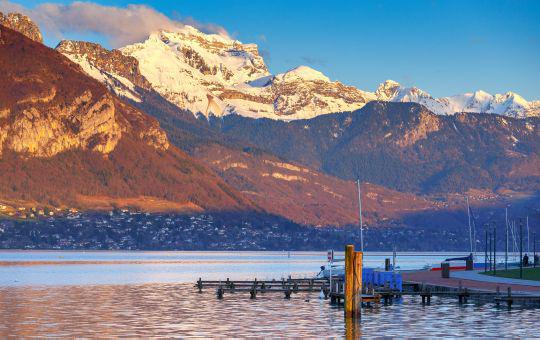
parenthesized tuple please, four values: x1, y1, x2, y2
(115, 26, 374, 120)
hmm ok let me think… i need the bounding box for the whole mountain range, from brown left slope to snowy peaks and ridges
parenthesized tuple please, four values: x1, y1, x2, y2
(0, 14, 540, 231)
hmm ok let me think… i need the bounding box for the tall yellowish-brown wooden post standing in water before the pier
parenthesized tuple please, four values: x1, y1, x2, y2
(345, 245, 363, 318)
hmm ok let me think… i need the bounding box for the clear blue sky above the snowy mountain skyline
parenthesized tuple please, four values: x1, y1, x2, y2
(8, 0, 540, 100)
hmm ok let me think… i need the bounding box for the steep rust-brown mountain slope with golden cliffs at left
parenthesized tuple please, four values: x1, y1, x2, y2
(0, 22, 253, 211)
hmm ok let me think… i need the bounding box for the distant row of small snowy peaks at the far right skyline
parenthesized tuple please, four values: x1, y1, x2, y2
(375, 80, 540, 118)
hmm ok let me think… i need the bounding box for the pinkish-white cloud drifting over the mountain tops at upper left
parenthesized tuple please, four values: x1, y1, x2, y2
(0, 0, 228, 47)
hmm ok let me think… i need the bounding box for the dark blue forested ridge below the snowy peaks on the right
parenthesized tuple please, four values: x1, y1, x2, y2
(210, 101, 540, 194)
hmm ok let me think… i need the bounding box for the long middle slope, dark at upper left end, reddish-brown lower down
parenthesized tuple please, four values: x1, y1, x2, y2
(130, 90, 438, 226)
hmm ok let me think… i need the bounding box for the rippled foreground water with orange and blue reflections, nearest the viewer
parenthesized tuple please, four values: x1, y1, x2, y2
(0, 283, 540, 337)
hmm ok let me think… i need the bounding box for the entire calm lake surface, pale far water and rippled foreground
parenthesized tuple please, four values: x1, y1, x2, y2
(0, 251, 540, 337)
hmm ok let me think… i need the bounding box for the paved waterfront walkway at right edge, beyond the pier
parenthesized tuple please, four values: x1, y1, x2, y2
(403, 270, 540, 294)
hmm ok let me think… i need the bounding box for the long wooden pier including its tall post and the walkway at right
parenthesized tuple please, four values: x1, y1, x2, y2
(195, 246, 540, 310)
